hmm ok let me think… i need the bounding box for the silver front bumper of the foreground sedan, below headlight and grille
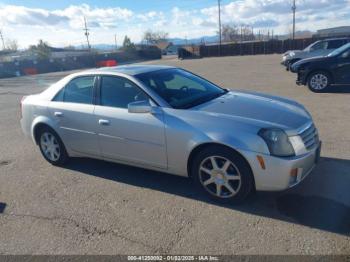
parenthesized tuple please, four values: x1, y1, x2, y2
(241, 142, 321, 191)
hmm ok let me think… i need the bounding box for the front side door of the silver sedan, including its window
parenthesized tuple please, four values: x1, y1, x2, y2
(95, 76, 167, 168)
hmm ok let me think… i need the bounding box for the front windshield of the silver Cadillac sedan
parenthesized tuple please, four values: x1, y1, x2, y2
(135, 68, 227, 109)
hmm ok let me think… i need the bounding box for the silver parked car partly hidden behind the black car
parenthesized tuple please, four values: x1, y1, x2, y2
(282, 38, 350, 70)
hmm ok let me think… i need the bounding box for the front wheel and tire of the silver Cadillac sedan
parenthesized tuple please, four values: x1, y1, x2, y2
(191, 146, 255, 204)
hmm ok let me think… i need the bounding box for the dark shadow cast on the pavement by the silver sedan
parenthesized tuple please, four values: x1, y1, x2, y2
(65, 158, 350, 236)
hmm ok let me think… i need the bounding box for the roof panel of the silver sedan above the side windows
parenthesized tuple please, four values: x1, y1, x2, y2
(82, 64, 175, 76)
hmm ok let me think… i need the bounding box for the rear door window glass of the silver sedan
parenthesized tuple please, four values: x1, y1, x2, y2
(63, 76, 95, 104)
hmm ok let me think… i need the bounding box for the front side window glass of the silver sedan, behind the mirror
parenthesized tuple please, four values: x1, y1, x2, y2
(100, 76, 148, 108)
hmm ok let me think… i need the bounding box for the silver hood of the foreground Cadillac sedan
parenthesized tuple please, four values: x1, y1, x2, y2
(195, 91, 311, 133)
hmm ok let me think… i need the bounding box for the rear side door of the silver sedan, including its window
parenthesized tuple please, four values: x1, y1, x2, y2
(49, 76, 100, 155)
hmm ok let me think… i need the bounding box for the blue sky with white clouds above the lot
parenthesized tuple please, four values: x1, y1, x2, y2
(0, 0, 350, 48)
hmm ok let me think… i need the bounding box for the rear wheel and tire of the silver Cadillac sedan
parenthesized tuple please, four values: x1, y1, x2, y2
(38, 127, 69, 166)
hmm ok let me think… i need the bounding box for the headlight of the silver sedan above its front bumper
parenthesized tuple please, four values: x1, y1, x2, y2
(258, 128, 295, 157)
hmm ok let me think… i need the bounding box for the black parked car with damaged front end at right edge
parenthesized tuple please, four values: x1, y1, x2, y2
(291, 43, 350, 92)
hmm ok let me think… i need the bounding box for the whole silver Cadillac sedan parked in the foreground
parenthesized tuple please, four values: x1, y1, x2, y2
(21, 65, 321, 202)
